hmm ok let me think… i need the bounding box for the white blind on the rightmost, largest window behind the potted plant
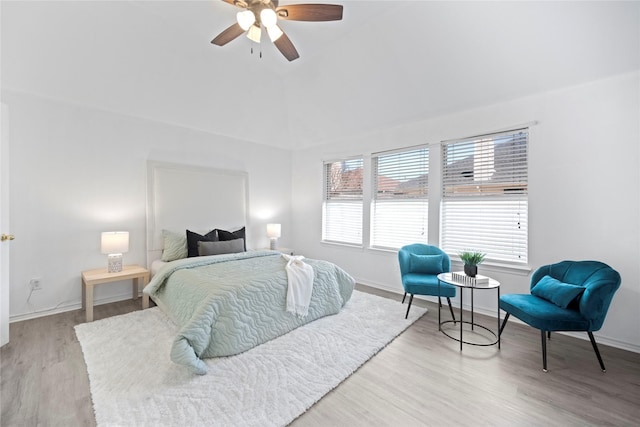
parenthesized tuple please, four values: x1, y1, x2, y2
(440, 129, 529, 263)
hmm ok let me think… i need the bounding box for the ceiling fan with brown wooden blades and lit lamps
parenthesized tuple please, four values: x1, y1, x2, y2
(211, 0, 342, 61)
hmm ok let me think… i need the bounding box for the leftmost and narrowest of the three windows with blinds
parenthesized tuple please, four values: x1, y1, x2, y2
(322, 158, 363, 245)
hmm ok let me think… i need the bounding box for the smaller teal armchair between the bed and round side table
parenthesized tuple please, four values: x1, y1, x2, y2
(398, 243, 456, 321)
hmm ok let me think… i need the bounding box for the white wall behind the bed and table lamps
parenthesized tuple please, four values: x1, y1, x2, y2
(2, 91, 291, 320)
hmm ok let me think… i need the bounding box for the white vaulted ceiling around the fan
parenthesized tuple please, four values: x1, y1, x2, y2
(0, 0, 640, 148)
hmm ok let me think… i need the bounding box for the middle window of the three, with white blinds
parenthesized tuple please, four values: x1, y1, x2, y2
(371, 147, 429, 249)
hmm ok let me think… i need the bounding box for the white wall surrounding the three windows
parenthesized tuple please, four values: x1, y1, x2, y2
(292, 72, 640, 351)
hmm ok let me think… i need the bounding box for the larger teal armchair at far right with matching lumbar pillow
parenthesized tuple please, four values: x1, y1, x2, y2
(500, 261, 621, 372)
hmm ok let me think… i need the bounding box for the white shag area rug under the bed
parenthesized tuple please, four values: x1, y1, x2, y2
(75, 291, 426, 427)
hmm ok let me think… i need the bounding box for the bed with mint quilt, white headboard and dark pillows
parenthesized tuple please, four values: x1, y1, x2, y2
(143, 162, 355, 375)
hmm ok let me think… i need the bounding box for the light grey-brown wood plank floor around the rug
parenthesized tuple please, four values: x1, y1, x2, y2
(0, 287, 640, 427)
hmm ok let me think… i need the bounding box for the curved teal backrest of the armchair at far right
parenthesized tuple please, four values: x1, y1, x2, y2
(531, 261, 621, 331)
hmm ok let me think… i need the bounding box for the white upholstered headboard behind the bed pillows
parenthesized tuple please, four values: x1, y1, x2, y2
(147, 160, 249, 267)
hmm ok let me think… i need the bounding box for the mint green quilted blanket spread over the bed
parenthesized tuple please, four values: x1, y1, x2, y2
(143, 251, 355, 375)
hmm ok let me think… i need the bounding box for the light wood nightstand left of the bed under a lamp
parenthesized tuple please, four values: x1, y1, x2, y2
(82, 265, 149, 322)
